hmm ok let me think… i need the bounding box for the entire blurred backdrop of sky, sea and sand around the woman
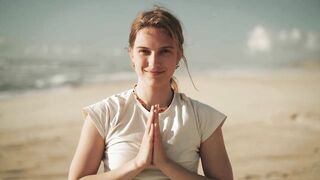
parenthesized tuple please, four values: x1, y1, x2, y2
(0, 0, 320, 180)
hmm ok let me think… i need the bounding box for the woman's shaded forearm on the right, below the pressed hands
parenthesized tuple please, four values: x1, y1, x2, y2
(160, 160, 210, 180)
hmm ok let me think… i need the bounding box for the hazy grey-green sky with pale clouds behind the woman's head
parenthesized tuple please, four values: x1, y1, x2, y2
(0, 0, 320, 67)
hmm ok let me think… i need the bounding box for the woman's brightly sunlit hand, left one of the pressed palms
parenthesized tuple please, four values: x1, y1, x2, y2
(135, 106, 155, 169)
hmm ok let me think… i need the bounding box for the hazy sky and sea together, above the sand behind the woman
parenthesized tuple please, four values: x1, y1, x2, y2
(0, 0, 320, 92)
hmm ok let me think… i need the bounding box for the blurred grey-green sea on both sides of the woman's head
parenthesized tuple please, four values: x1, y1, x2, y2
(0, 56, 319, 97)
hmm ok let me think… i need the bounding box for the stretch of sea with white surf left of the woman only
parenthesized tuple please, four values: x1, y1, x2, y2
(0, 58, 135, 93)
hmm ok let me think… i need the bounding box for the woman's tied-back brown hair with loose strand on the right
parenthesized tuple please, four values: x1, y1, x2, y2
(129, 7, 197, 91)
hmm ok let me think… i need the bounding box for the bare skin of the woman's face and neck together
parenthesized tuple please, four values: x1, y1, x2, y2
(129, 27, 181, 107)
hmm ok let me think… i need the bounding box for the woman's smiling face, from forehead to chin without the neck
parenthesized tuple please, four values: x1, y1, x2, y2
(129, 27, 181, 87)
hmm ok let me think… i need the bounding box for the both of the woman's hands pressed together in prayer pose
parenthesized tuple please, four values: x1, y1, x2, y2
(135, 105, 169, 169)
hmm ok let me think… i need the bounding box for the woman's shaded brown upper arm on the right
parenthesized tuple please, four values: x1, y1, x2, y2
(200, 125, 233, 179)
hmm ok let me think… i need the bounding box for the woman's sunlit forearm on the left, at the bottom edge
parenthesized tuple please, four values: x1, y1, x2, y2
(81, 159, 144, 180)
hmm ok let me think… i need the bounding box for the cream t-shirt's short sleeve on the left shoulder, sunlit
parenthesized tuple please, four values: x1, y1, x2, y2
(82, 101, 109, 139)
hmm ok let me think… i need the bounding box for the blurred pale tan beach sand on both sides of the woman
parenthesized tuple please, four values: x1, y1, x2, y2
(0, 69, 320, 180)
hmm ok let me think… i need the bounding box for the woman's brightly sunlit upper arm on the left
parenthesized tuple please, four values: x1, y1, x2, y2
(68, 119, 105, 180)
